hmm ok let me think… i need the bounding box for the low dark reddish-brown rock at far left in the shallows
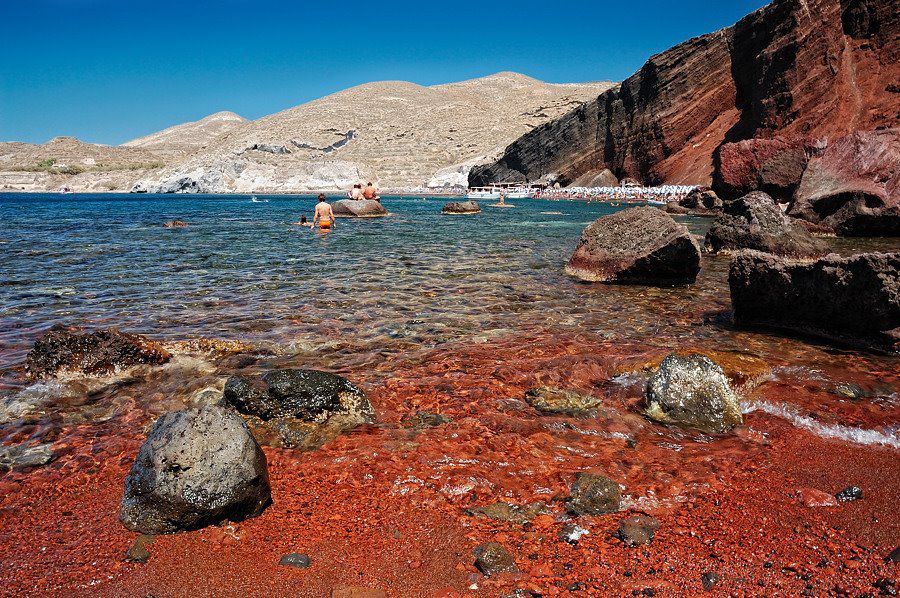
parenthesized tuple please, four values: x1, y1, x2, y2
(25, 325, 170, 379)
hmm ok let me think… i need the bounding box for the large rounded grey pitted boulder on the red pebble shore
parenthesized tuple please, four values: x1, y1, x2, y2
(119, 406, 272, 534)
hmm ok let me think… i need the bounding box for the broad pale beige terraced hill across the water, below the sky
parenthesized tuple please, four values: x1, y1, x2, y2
(135, 73, 612, 193)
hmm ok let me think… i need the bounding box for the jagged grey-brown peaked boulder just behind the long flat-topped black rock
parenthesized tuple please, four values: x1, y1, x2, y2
(706, 191, 827, 257)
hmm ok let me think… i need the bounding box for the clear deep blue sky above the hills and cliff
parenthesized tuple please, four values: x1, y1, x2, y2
(0, 0, 765, 144)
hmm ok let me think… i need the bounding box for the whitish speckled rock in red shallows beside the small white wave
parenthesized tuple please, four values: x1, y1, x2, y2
(645, 353, 743, 434)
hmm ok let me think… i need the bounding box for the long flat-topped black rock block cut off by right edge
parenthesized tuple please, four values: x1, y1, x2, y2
(728, 251, 900, 351)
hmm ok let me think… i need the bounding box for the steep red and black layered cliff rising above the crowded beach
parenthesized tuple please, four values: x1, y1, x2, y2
(470, 0, 900, 184)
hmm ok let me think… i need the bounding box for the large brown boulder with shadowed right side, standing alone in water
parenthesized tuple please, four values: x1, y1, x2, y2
(566, 207, 700, 285)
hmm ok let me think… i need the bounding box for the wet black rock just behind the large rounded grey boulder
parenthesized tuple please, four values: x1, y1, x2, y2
(223, 370, 375, 450)
